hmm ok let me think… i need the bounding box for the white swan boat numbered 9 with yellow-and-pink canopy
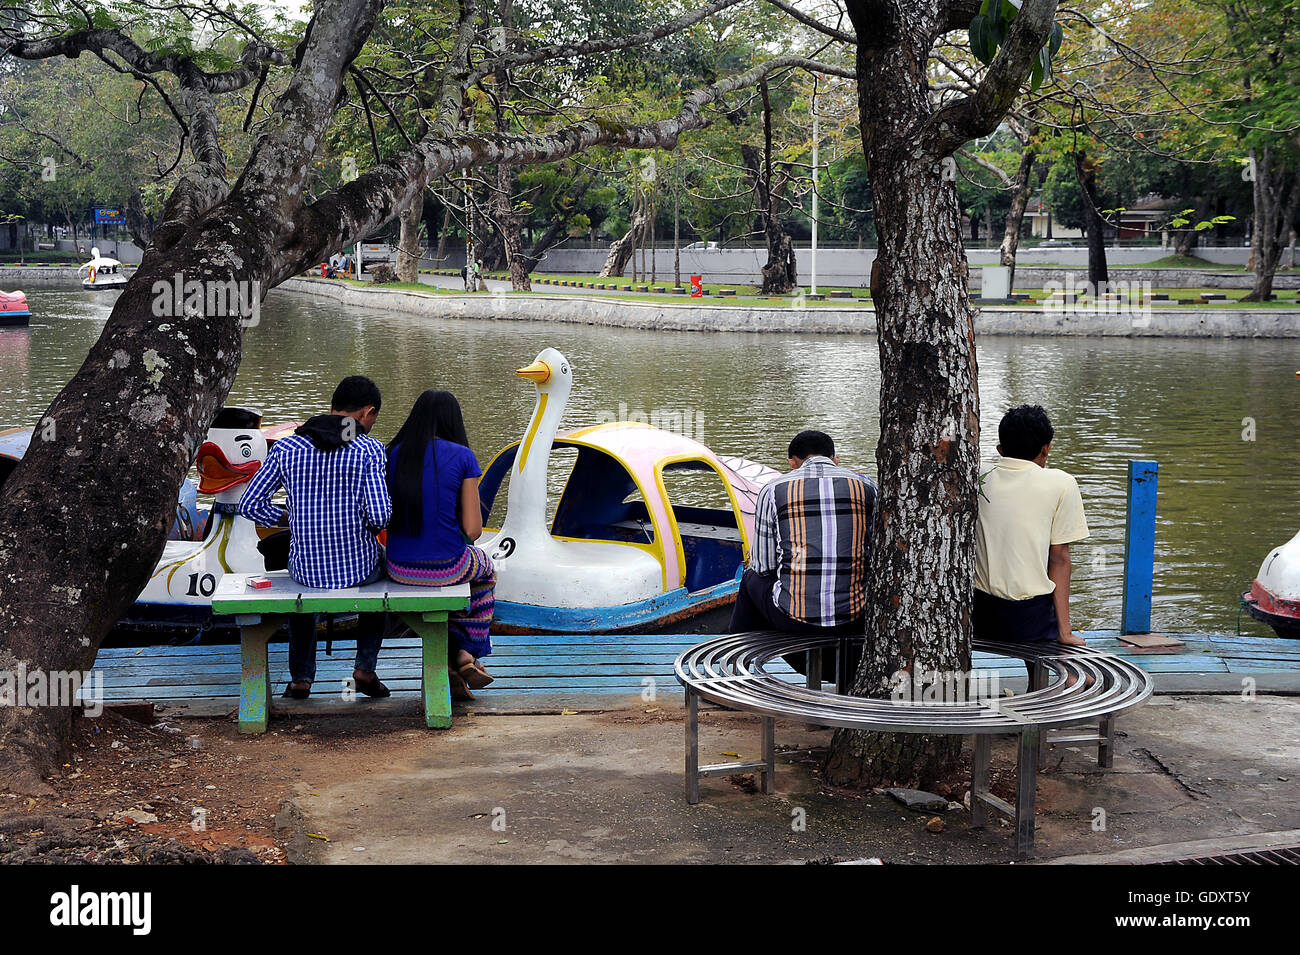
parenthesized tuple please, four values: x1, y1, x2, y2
(478, 348, 776, 633)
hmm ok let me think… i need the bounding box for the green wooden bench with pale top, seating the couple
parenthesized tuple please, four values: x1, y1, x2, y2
(212, 570, 469, 733)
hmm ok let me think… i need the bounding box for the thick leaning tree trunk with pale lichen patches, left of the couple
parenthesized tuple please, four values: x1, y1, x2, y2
(0, 1, 380, 791)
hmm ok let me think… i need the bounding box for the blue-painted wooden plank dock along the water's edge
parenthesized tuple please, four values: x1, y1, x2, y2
(95, 630, 1300, 716)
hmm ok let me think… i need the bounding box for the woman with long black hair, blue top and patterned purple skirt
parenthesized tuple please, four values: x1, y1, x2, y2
(386, 390, 497, 699)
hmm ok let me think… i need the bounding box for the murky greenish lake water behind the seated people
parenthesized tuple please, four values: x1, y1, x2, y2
(0, 287, 1300, 635)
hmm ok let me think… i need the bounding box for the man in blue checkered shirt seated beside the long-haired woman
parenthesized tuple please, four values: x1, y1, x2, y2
(239, 374, 393, 699)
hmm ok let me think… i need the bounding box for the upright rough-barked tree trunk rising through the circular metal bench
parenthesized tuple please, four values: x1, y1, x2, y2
(826, 8, 979, 786)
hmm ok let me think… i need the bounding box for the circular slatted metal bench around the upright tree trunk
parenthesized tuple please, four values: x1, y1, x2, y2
(675, 630, 1153, 858)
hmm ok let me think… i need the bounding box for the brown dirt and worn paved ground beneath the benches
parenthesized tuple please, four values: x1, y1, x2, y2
(0, 696, 1300, 864)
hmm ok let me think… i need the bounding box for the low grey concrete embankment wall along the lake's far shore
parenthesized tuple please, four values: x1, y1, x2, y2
(280, 278, 1300, 338)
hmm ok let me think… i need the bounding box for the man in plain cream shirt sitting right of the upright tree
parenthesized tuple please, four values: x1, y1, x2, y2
(974, 404, 1088, 644)
